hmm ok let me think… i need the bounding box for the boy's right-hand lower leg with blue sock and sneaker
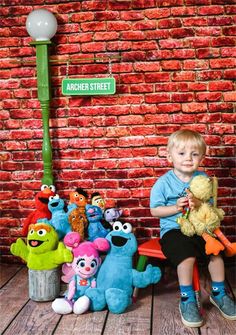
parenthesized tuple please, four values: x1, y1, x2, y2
(208, 255, 236, 320)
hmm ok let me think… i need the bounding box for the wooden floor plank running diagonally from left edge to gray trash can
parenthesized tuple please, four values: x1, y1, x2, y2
(0, 267, 29, 333)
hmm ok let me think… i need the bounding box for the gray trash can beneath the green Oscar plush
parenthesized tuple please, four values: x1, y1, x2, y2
(28, 268, 60, 301)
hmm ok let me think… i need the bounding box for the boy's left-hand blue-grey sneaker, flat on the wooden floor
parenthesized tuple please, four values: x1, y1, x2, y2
(179, 301, 203, 327)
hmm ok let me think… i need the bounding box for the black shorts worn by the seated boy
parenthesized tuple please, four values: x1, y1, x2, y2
(160, 229, 209, 266)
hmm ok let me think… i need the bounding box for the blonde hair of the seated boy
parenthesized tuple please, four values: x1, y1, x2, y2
(167, 129, 206, 155)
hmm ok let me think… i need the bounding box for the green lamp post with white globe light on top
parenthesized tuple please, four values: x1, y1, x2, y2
(26, 9, 57, 185)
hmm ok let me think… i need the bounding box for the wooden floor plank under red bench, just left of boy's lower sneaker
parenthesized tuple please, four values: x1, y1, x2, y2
(152, 280, 199, 335)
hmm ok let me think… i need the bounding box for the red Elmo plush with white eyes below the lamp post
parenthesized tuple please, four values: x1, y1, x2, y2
(22, 185, 55, 236)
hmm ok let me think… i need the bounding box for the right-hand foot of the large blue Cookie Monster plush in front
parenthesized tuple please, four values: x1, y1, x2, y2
(105, 288, 132, 314)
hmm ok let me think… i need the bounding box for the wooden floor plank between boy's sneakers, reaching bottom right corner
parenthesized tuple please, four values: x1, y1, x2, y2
(201, 273, 235, 335)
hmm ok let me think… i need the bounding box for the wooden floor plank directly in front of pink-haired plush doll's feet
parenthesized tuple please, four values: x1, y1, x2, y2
(53, 311, 107, 335)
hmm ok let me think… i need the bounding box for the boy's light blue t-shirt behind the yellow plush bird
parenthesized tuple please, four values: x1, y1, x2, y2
(150, 170, 206, 237)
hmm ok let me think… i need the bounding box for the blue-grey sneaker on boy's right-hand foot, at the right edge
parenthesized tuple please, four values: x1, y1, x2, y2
(210, 294, 236, 320)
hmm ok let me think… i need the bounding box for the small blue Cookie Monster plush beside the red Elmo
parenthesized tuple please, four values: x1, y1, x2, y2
(48, 194, 71, 240)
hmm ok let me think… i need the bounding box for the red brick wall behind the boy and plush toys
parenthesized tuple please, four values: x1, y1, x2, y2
(0, 0, 236, 261)
